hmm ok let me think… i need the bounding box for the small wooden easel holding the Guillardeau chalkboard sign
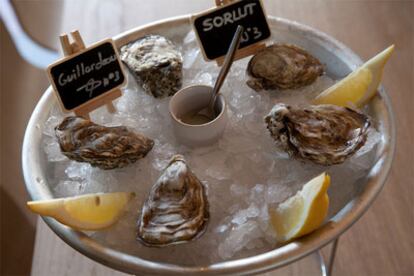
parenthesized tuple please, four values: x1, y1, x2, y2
(59, 30, 122, 119)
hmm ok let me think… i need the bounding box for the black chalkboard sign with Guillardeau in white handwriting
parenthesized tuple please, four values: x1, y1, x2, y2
(48, 39, 125, 111)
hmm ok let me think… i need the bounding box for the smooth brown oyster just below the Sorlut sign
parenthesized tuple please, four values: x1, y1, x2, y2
(247, 44, 323, 91)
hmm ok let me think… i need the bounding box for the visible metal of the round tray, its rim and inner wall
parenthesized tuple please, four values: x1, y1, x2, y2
(22, 16, 396, 275)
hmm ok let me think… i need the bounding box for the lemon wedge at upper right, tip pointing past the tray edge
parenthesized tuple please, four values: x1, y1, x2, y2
(313, 45, 394, 107)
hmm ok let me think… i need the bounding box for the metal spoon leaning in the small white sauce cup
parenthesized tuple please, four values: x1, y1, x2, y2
(194, 25, 244, 120)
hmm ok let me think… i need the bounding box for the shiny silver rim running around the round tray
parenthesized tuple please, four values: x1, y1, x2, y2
(22, 15, 396, 275)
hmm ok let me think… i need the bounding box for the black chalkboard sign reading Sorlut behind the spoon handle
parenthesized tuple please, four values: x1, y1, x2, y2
(192, 0, 270, 60)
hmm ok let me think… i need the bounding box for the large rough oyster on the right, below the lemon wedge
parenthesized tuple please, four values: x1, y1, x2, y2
(265, 104, 370, 165)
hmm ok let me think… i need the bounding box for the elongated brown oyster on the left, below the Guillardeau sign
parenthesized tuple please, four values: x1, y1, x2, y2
(55, 116, 154, 170)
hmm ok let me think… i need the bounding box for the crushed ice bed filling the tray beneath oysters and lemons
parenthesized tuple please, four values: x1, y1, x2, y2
(43, 31, 380, 265)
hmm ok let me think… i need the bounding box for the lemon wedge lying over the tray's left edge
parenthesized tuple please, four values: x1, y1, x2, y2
(27, 192, 135, 230)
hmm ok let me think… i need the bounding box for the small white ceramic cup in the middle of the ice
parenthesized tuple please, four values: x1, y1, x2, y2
(169, 85, 227, 146)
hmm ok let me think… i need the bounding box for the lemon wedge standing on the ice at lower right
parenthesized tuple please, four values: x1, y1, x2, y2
(269, 173, 330, 242)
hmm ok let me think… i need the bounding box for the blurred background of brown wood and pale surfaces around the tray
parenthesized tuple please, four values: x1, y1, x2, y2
(0, 0, 414, 275)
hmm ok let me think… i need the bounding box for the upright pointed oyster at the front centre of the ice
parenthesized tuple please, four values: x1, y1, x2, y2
(137, 155, 209, 247)
